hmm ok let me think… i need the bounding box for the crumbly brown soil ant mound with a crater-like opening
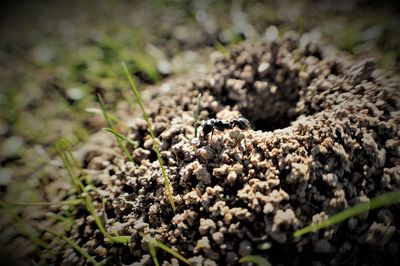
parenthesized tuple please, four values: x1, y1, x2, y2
(49, 36, 400, 265)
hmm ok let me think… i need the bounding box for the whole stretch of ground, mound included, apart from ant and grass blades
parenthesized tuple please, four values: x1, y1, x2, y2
(1, 2, 400, 265)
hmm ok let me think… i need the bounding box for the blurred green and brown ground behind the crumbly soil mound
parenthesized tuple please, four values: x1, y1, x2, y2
(0, 0, 400, 264)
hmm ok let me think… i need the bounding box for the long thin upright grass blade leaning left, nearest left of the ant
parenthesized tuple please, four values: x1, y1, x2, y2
(122, 63, 176, 214)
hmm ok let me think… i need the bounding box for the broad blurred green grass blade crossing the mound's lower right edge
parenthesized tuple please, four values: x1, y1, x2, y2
(293, 190, 400, 237)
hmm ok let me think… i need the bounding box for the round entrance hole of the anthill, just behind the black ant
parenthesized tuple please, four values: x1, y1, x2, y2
(206, 43, 306, 131)
